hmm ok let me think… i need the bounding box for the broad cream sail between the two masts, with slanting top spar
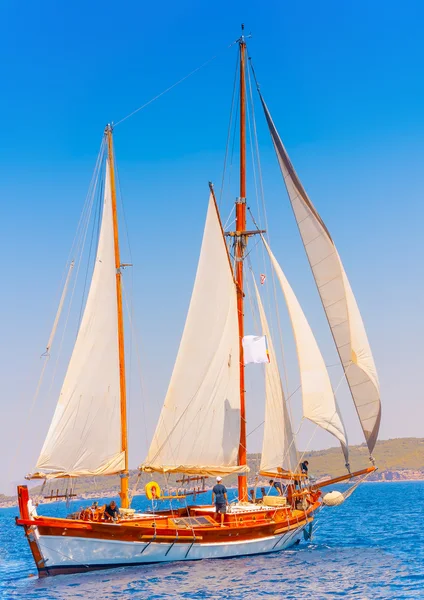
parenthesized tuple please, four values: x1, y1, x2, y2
(140, 195, 247, 475)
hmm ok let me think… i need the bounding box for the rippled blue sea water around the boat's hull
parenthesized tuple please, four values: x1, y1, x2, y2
(0, 482, 424, 600)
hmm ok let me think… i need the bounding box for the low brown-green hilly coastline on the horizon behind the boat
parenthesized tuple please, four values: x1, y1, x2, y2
(0, 438, 424, 506)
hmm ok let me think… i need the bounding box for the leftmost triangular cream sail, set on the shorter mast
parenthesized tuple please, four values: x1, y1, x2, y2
(34, 162, 124, 477)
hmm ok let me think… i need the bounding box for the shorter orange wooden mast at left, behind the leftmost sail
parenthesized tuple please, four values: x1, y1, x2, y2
(105, 125, 129, 508)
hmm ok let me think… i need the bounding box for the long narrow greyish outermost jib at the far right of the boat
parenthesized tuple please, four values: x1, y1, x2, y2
(261, 96, 381, 453)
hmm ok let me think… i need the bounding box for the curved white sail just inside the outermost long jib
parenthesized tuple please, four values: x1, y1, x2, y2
(263, 238, 348, 462)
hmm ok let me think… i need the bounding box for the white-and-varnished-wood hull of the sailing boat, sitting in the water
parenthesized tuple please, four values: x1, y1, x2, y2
(17, 488, 319, 577)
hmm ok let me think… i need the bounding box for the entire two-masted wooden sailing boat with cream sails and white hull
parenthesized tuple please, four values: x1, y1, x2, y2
(17, 36, 380, 576)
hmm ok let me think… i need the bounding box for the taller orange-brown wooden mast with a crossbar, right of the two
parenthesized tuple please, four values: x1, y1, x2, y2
(235, 31, 248, 502)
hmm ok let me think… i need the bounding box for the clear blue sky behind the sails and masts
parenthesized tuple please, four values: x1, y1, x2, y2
(0, 0, 424, 491)
